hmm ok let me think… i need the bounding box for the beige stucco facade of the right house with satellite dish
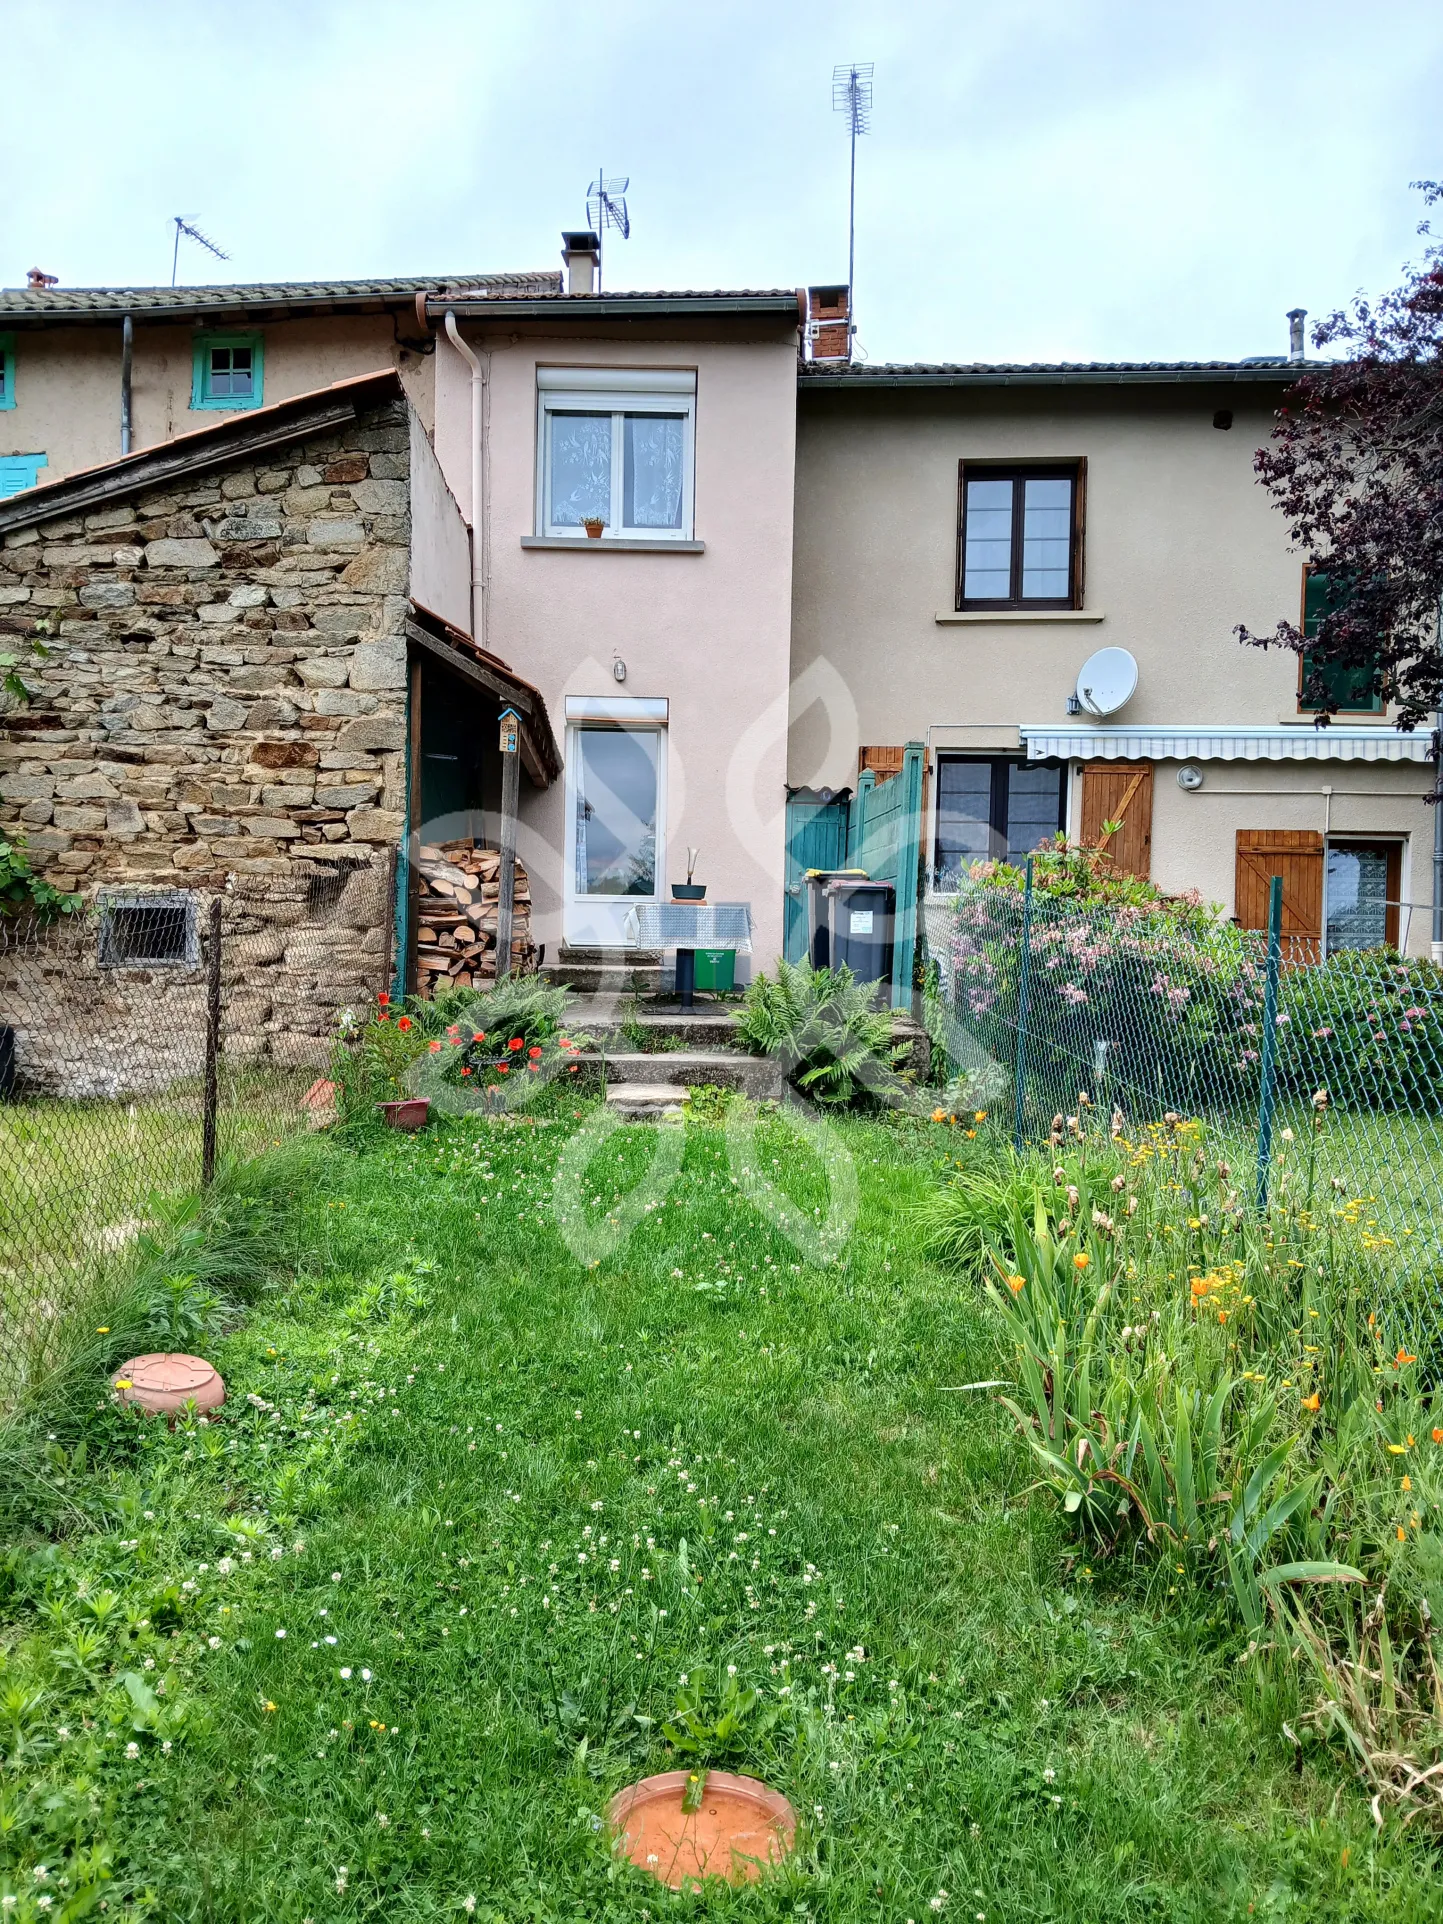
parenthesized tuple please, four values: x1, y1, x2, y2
(787, 382, 1433, 954)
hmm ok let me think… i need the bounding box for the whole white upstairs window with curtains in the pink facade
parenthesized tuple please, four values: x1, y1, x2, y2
(537, 367, 696, 541)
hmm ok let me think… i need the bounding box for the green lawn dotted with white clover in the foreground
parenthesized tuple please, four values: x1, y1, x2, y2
(0, 1108, 1437, 1924)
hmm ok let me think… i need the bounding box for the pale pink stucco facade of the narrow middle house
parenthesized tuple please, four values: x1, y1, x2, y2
(435, 319, 797, 968)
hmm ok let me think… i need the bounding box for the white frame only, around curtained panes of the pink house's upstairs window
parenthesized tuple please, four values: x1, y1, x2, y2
(535, 367, 696, 544)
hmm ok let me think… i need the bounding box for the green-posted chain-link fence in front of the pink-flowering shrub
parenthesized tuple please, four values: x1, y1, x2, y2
(924, 864, 1443, 1339)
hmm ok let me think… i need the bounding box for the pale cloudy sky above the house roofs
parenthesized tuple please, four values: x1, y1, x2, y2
(0, 0, 1443, 362)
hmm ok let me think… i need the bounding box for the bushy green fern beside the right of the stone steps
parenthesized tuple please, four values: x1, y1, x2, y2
(737, 958, 906, 1106)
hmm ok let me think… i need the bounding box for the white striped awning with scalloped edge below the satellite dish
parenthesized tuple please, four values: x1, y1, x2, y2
(1020, 722, 1433, 762)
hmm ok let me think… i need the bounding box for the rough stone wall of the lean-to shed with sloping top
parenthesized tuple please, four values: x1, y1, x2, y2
(0, 402, 412, 1093)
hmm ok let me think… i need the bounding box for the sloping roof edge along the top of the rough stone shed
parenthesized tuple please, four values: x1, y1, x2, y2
(0, 367, 404, 535)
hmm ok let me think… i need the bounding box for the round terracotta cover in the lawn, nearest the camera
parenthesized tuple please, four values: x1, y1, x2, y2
(606, 1770, 797, 1891)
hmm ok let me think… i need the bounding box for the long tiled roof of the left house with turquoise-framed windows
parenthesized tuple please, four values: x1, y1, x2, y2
(0, 267, 562, 323)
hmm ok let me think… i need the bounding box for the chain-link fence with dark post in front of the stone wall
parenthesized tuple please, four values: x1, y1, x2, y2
(0, 856, 391, 1408)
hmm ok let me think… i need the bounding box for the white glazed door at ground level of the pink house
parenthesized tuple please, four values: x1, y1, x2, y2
(566, 722, 666, 949)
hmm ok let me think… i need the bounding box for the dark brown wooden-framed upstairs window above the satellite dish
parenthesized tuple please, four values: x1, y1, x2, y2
(956, 460, 1087, 608)
